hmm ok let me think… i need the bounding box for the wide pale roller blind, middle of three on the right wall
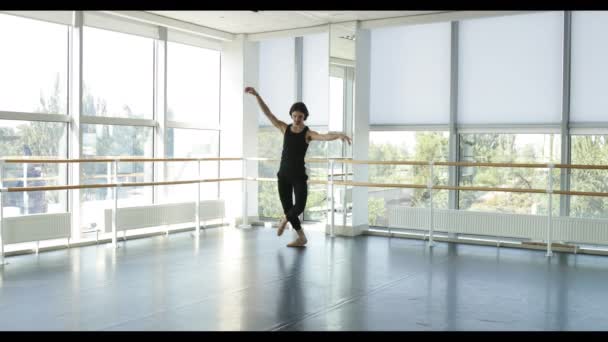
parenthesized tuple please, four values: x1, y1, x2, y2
(458, 12, 563, 124)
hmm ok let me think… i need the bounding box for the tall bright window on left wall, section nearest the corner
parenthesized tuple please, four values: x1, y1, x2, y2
(161, 42, 220, 206)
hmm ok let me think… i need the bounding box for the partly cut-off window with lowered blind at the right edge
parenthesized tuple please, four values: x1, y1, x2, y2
(570, 11, 608, 218)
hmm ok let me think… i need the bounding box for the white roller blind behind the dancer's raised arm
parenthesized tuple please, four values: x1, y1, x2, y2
(258, 37, 296, 126)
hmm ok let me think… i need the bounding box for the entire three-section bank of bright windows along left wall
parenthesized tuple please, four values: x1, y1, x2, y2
(0, 11, 220, 246)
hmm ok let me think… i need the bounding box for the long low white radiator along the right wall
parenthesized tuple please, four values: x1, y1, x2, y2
(387, 206, 608, 244)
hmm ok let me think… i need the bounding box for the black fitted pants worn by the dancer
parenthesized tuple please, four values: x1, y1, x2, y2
(277, 175, 308, 230)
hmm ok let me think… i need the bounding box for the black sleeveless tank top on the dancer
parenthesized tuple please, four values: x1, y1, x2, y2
(278, 124, 308, 178)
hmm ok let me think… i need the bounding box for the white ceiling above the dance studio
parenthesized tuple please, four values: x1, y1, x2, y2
(148, 11, 444, 34)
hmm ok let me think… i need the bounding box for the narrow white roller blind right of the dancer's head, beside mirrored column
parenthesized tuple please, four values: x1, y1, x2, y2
(302, 32, 329, 126)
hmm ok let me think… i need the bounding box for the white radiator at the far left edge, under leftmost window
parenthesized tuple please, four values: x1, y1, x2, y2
(2, 213, 71, 245)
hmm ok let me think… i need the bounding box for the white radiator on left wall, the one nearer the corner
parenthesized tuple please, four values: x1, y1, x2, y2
(104, 200, 225, 233)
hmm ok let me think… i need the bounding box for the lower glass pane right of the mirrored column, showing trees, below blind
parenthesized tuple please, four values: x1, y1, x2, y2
(368, 131, 449, 226)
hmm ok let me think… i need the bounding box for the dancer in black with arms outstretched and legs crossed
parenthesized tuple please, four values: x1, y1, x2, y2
(245, 87, 351, 247)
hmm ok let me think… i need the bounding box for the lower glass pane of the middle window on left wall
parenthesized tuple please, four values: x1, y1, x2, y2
(80, 124, 153, 235)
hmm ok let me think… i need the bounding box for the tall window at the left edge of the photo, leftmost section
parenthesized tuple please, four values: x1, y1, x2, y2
(0, 14, 68, 216)
